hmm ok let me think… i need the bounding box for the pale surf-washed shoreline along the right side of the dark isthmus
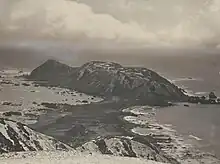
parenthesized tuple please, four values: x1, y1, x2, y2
(122, 106, 220, 164)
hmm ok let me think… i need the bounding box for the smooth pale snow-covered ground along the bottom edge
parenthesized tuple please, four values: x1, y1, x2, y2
(0, 151, 166, 164)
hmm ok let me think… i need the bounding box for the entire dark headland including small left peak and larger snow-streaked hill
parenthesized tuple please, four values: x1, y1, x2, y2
(28, 60, 187, 104)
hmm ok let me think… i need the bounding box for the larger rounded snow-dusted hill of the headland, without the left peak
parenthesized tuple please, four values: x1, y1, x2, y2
(69, 61, 184, 100)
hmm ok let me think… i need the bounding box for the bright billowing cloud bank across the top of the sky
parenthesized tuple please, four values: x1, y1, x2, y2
(0, 0, 220, 47)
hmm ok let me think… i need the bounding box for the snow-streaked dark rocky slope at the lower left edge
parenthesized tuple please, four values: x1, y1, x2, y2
(0, 118, 72, 153)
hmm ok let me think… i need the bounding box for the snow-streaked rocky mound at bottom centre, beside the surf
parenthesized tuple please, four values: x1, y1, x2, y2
(77, 137, 176, 163)
